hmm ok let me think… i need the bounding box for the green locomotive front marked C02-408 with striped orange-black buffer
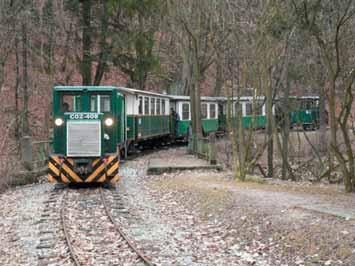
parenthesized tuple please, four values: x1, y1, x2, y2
(48, 86, 125, 183)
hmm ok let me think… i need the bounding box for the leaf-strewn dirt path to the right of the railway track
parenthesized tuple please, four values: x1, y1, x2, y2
(121, 147, 355, 265)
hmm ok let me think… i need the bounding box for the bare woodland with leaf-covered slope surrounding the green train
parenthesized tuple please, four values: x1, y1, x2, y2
(0, 0, 355, 192)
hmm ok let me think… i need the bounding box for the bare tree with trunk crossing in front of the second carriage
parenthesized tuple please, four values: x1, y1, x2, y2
(168, 0, 225, 150)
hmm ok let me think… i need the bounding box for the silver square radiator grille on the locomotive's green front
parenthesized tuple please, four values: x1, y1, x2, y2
(67, 121, 101, 157)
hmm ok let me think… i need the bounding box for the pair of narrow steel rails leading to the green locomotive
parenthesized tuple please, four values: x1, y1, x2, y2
(60, 188, 154, 266)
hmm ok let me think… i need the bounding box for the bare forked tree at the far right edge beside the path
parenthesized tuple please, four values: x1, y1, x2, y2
(292, 0, 355, 192)
